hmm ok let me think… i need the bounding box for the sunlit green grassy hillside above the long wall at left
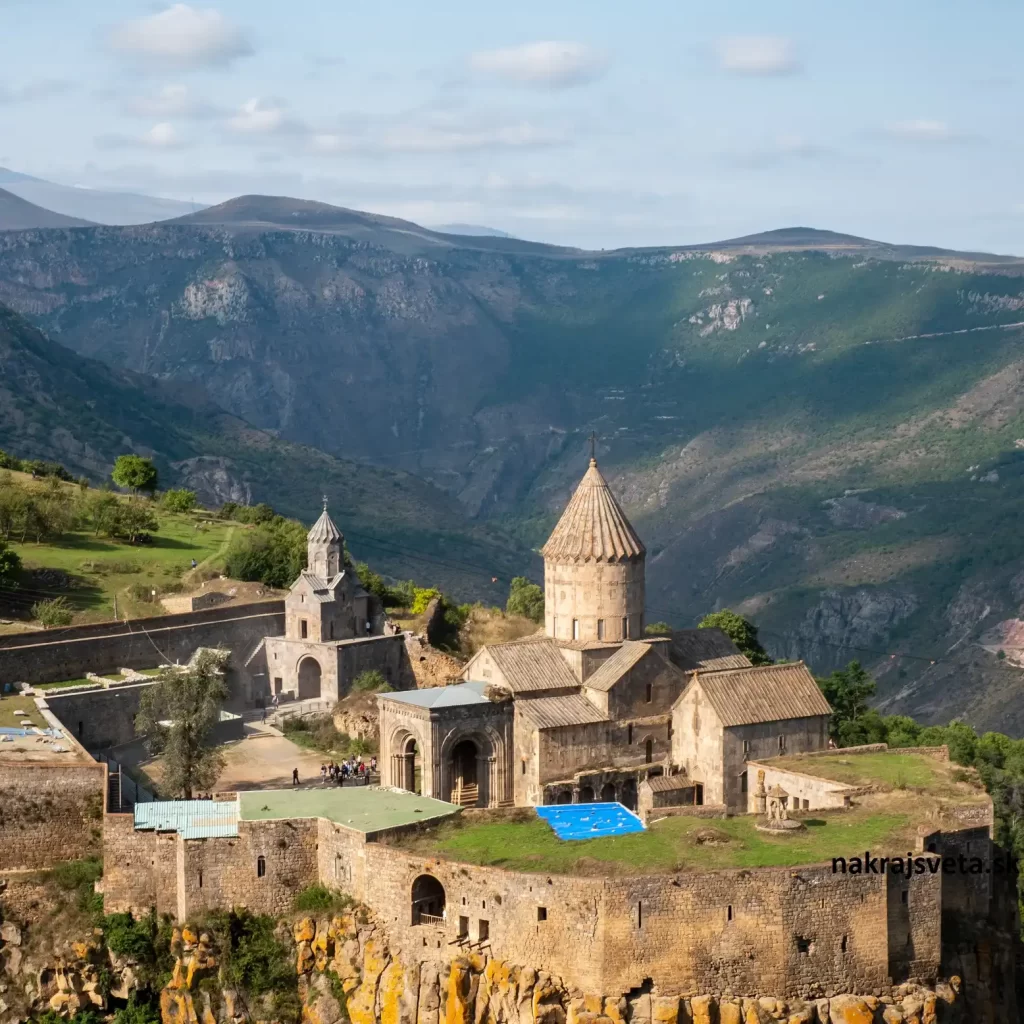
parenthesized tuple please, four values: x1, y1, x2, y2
(11, 510, 239, 622)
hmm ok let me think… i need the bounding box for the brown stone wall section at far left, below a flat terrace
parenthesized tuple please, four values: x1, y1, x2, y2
(0, 761, 106, 870)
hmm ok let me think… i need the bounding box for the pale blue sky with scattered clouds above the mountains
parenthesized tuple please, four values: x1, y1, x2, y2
(0, 0, 1024, 254)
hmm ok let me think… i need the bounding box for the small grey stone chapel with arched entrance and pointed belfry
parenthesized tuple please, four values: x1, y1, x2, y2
(264, 500, 402, 700)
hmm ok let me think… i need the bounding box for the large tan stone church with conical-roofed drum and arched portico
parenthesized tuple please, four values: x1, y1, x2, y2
(378, 459, 830, 811)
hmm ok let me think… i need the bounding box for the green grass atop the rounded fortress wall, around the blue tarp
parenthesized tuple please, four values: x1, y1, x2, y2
(387, 807, 915, 876)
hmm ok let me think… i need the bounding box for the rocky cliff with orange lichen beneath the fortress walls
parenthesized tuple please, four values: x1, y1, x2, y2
(0, 912, 999, 1024)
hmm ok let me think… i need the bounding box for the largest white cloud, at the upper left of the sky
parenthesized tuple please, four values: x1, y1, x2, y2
(111, 3, 253, 68)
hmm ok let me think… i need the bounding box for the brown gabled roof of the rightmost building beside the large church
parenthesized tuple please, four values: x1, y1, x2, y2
(687, 662, 831, 727)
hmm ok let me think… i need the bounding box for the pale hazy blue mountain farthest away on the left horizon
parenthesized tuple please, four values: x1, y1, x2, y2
(0, 167, 197, 230)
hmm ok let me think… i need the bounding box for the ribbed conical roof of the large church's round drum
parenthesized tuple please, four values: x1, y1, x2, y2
(541, 459, 646, 562)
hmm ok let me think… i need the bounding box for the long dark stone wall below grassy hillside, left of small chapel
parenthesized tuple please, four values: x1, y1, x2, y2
(0, 601, 285, 700)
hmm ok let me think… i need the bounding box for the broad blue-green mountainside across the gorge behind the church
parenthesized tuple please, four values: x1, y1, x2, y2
(0, 196, 1024, 734)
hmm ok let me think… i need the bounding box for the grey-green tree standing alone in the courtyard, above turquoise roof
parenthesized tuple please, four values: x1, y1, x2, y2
(135, 650, 227, 800)
